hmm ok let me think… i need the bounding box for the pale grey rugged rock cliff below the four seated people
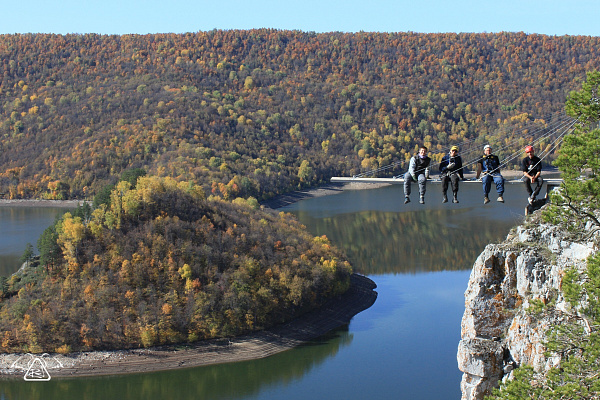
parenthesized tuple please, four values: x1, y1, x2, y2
(457, 216, 597, 400)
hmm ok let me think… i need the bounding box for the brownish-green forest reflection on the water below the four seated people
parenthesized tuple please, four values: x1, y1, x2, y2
(295, 208, 514, 275)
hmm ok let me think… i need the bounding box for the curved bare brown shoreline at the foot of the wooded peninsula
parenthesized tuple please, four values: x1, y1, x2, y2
(0, 274, 377, 380)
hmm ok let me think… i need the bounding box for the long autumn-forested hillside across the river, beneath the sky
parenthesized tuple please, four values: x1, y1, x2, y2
(0, 30, 600, 199)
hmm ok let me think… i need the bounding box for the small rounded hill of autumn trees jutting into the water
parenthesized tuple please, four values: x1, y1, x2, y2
(0, 177, 351, 353)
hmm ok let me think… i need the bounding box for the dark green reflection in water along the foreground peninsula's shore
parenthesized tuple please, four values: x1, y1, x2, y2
(0, 325, 352, 400)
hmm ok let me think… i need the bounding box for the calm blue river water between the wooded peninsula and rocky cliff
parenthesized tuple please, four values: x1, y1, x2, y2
(0, 184, 526, 400)
